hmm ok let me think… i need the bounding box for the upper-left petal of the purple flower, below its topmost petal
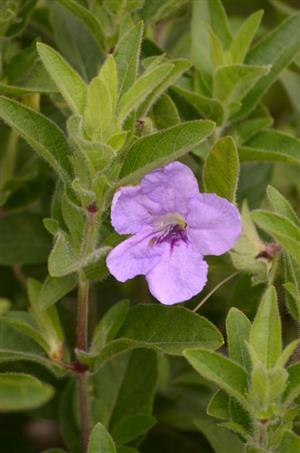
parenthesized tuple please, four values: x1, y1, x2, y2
(111, 186, 162, 234)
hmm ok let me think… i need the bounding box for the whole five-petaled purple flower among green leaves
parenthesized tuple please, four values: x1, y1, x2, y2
(107, 162, 241, 305)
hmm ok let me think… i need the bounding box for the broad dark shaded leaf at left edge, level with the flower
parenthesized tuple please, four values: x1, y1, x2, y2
(0, 212, 51, 266)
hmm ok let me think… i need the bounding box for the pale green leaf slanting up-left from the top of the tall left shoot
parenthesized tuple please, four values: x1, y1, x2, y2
(37, 42, 86, 115)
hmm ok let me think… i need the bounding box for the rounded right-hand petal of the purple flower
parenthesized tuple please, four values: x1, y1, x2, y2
(186, 194, 241, 256)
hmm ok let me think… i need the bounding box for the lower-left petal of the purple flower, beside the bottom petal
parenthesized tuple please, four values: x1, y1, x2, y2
(106, 233, 163, 282)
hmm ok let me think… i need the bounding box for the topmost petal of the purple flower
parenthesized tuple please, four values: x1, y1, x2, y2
(141, 162, 199, 215)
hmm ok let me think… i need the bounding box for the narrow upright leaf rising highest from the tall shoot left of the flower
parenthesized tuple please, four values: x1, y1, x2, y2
(114, 22, 143, 96)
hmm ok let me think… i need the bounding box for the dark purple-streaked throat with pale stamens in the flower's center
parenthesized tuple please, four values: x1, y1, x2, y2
(150, 212, 187, 247)
